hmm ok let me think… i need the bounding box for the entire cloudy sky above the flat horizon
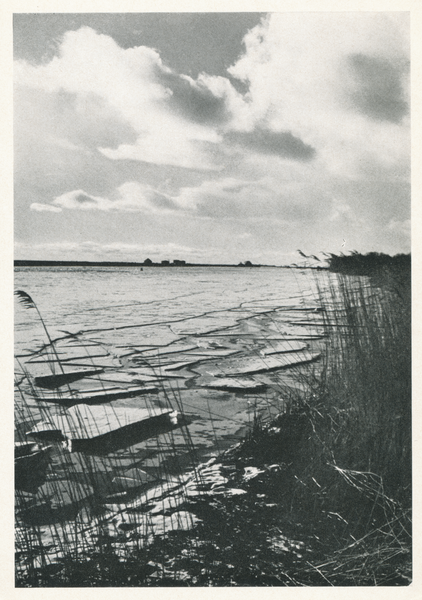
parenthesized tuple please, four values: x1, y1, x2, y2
(14, 12, 410, 264)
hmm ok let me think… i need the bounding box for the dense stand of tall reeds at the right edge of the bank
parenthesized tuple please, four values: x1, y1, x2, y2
(313, 275, 411, 501)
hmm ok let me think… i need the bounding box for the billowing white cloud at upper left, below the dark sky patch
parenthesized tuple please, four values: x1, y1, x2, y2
(15, 27, 240, 170)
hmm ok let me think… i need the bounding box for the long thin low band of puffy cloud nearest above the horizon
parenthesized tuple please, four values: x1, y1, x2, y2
(42, 177, 330, 222)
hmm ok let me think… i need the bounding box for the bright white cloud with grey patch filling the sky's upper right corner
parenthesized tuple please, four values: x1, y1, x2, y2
(229, 12, 409, 176)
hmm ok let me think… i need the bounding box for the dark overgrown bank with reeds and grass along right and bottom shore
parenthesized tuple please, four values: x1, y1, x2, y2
(16, 254, 412, 587)
